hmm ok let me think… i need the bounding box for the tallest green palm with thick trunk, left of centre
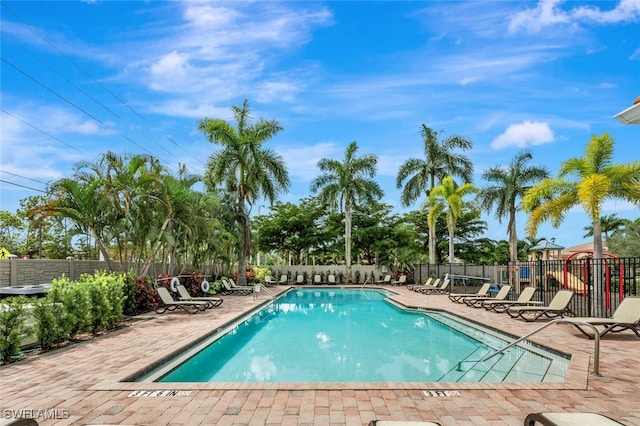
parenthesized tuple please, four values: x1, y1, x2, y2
(198, 99, 289, 285)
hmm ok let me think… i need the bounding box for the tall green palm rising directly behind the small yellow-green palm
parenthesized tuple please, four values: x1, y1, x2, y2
(396, 124, 473, 263)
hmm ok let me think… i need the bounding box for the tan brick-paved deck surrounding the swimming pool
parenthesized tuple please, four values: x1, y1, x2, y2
(0, 287, 640, 425)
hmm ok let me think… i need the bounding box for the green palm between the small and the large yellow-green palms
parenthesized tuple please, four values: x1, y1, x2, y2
(479, 151, 549, 262)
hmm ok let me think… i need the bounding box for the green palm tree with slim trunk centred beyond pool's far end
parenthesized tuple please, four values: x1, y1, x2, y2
(311, 141, 383, 282)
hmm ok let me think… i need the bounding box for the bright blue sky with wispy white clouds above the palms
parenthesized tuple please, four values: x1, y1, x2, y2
(0, 0, 640, 246)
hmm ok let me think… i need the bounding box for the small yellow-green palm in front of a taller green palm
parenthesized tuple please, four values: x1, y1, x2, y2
(429, 176, 477, 263)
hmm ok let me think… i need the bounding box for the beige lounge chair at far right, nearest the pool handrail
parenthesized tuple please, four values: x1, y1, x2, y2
(565, 296, 640, 339)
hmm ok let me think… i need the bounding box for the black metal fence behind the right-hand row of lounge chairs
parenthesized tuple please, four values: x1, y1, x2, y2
(414, 257, 640, 317)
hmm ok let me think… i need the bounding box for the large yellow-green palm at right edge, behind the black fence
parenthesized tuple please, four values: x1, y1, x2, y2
(522, 133, 640, 307)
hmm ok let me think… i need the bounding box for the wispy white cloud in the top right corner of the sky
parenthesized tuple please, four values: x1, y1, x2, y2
(509, 0, 640, 33)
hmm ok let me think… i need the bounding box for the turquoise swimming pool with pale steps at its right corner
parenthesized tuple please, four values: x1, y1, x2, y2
(134, 288, 568, 383)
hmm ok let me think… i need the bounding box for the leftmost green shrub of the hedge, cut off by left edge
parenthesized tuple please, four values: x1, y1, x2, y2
(0, 296, 31, 363)
